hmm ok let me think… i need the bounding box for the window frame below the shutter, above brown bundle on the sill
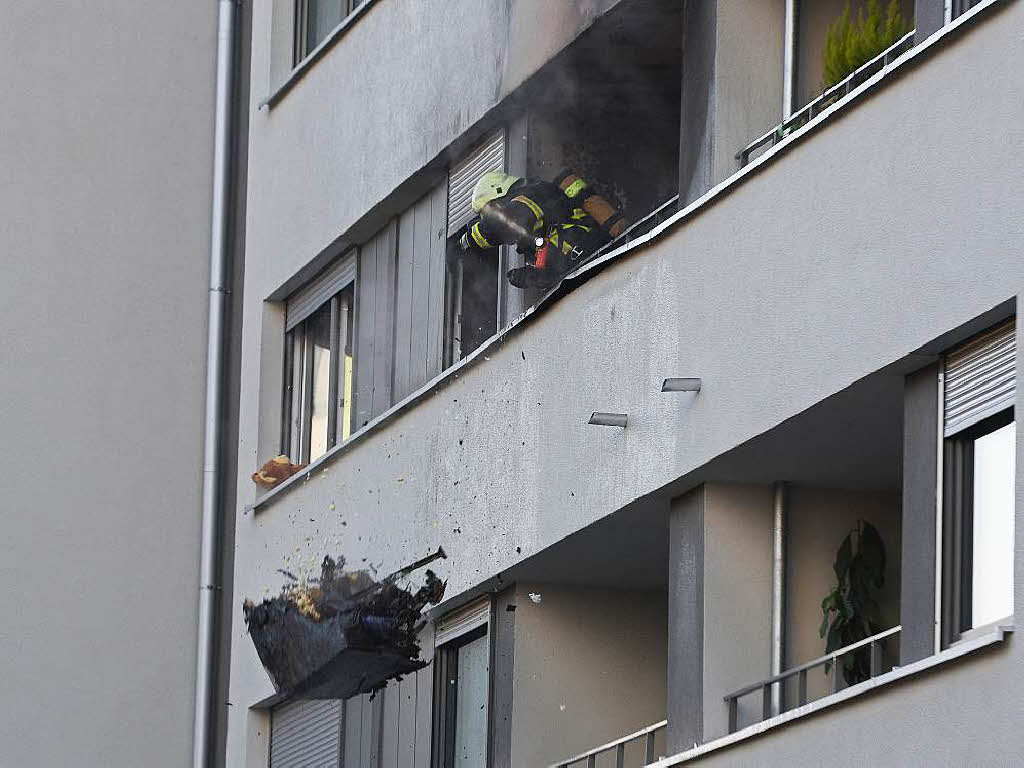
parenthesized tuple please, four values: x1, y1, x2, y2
(280, 276, 356, 464)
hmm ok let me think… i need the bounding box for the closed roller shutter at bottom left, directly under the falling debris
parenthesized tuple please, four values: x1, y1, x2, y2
(270, 699, 344, 768)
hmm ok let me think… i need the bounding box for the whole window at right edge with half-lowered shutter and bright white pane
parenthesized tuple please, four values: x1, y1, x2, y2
(942, 321, 1017, 645)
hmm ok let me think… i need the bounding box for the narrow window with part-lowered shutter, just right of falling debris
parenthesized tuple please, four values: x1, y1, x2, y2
(432, 599, 490, 768)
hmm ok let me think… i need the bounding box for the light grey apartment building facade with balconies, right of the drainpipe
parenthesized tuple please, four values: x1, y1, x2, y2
(225, 0, 1024, 768)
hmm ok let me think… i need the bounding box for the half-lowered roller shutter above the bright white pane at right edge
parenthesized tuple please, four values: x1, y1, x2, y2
(943, 319, 1017, 437)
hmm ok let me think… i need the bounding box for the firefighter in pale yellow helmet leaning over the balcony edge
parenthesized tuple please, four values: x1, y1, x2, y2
(459, 171, 610, 289)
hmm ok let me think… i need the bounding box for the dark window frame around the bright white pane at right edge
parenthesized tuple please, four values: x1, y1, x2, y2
(941, 407, 1016, 648)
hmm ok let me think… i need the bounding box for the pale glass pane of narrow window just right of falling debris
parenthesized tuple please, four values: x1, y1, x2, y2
(454, 635, 488, 768)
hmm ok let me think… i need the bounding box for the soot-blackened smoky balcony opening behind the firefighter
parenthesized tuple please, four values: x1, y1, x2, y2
(526, 0, 683, 230)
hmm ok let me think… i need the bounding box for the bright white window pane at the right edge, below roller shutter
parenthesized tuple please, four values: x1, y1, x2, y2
(971, 422, 1017, 627)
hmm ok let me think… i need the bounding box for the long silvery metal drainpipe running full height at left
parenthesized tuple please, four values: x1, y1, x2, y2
(193, 0, 237, 768)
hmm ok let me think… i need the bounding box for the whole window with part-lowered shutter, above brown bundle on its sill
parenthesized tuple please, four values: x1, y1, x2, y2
(281, 256, 355, 464)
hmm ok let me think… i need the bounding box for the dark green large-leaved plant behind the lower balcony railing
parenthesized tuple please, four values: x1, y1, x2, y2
(819, 520, 886, 685)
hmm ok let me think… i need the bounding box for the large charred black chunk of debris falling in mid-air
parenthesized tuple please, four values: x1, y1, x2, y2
(243, 548, 446, 699)
